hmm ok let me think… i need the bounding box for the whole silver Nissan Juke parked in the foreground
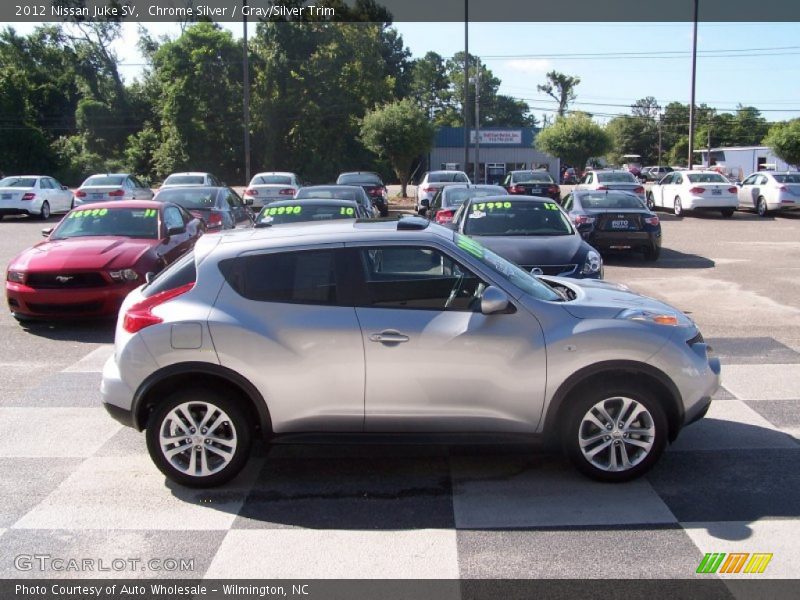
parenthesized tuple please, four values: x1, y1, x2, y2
(101, 217, 720, 487)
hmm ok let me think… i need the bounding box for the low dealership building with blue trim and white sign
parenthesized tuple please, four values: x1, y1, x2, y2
(428, 127, 560, 183)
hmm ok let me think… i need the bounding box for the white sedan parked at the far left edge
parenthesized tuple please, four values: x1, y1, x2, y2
(0, 175, 73, 220)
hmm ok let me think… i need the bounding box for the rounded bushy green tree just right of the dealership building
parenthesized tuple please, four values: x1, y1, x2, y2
(533, 112, 612, 169)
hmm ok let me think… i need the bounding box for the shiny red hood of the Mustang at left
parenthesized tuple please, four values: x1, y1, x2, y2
(9, 236, 160, 271)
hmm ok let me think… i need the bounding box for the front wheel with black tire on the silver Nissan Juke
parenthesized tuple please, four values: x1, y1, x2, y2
(561, 380, 668, 483)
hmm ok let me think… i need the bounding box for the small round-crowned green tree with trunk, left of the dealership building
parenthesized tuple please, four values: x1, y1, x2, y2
(361, 99, 434, 198)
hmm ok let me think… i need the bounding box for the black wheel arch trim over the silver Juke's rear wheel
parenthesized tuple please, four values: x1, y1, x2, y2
(131, 362, 272, 436)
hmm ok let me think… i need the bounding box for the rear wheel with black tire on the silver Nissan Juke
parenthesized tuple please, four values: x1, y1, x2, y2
(146, 388, 252, 488)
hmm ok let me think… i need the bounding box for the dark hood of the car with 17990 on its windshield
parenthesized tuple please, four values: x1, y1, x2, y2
(470, 235, 585, 265)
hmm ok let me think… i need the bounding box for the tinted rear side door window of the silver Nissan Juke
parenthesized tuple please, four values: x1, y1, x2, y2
(219, 250, 339, 305)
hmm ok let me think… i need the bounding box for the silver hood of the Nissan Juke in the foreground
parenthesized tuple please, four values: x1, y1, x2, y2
(542, 276, 691, 322)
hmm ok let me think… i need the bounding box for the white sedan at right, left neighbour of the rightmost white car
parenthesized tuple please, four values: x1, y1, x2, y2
(647, 171, 738, 217)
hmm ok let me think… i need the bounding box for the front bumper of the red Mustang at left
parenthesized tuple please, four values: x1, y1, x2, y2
(6, 281, 141, 318)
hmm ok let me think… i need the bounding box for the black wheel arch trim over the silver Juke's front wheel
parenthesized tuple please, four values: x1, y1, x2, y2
(542, 360, 686, 441)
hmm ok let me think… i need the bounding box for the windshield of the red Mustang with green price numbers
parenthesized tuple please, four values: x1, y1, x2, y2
(50, 208, 158, 240)
